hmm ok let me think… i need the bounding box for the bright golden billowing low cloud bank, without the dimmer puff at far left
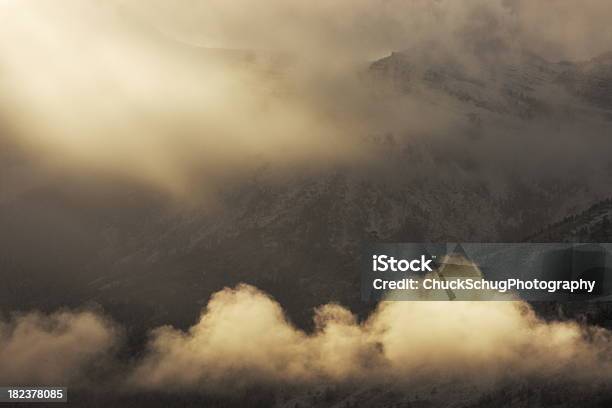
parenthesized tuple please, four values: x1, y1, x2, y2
(131, 285, 612, 391)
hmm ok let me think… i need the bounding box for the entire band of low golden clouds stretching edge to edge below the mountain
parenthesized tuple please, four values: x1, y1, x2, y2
(0, 284, 612, 393)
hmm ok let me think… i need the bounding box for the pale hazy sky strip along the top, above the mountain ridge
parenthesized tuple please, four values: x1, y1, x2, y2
(122, 0, 612, 59)
